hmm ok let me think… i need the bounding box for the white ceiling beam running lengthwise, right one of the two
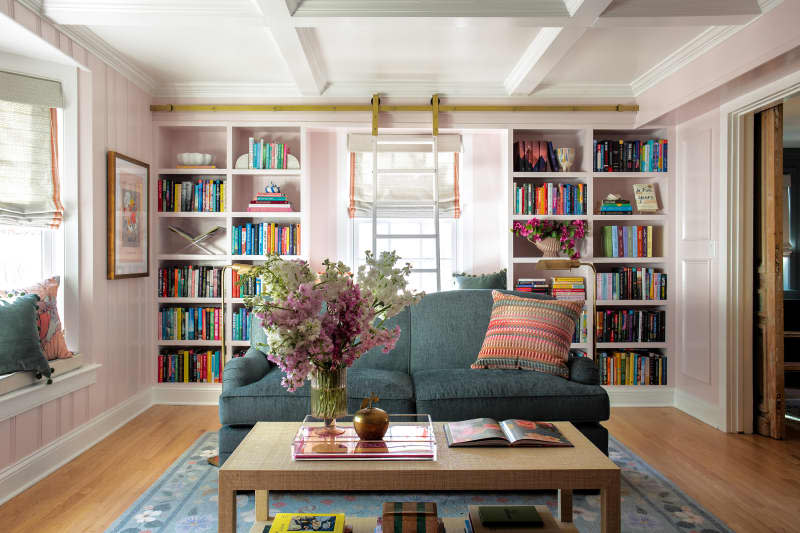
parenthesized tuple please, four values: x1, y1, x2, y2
(504, 0, 611, 95)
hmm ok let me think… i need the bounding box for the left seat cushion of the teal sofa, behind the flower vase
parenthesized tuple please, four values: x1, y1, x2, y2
(219, 367, 415, 425)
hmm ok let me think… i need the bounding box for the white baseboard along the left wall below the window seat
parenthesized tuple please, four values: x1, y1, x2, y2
(0, 388, 153, 505)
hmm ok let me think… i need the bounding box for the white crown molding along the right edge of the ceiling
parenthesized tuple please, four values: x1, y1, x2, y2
(631, 0, 783, 96)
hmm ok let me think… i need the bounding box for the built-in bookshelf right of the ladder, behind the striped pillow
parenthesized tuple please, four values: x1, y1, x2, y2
(507, 127, 675, 405)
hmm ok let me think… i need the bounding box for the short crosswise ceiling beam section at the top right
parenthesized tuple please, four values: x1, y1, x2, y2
(596, 0, 761, 27)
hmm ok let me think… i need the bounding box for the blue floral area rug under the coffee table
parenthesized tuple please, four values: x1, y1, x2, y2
(107, 433, 731, 533)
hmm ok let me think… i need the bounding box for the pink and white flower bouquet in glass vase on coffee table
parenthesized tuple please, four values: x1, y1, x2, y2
(240, 252, 424, 433)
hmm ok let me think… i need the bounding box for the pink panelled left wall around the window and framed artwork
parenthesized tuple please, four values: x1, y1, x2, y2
(0, 0, 152, 469)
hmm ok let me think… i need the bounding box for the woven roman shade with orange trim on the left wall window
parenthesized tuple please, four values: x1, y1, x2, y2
(0, 72, 64, 228)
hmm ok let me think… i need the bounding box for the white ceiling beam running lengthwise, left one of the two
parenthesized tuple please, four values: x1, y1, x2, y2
(253, 0, 328, 96)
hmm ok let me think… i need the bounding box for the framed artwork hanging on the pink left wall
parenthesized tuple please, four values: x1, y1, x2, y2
(106, 151, 150, 279)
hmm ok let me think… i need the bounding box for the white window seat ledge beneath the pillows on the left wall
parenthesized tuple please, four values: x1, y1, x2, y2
(0, 354, 100, 421)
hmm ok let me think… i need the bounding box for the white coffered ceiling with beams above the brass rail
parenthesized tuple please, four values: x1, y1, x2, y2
(14, 0, 781, 99)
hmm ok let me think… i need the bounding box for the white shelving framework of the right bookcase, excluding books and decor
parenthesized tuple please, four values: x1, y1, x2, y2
(504, 125, 677, 400)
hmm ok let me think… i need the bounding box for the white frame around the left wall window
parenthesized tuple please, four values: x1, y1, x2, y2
(0, 52, 79, 353)
